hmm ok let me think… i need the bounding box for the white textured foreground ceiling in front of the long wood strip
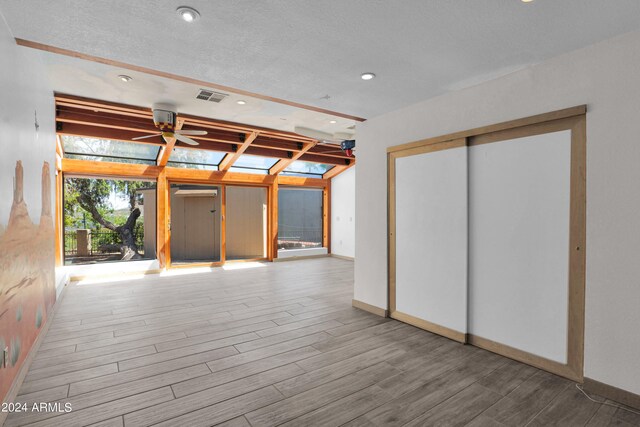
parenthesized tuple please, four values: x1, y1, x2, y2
(0, 0, 640, 120)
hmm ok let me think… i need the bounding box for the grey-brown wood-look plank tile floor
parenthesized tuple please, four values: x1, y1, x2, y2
(5, 258, 640, 427)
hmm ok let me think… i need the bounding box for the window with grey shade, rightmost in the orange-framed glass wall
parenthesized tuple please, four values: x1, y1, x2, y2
(278, 188, 322, 249)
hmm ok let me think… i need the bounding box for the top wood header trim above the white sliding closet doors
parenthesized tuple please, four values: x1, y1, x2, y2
(387, 105, 587, 153)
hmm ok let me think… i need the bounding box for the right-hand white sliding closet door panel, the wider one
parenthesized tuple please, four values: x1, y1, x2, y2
(469, 130, 571, 364)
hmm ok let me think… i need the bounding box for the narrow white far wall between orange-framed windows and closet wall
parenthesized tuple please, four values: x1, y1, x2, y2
(331, 166, 356, 258)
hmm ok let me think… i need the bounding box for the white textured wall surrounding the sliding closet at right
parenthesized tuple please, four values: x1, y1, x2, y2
(354, 32, 640, 393)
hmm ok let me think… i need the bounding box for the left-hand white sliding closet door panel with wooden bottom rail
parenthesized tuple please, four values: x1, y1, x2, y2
(391, 145, 467, 341)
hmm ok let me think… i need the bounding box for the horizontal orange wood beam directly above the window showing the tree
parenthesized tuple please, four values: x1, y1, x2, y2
(62, 158, 162, 179)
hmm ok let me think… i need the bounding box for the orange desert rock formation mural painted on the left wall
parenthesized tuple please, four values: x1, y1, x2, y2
(0, 161, 56, 402)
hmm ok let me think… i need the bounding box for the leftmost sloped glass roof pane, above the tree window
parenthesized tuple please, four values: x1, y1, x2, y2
(61, 135, 160, 164)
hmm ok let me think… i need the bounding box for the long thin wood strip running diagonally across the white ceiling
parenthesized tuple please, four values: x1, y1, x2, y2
(15, 38, 365, 122)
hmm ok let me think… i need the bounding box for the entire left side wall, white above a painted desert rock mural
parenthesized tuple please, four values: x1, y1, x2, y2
(0, 14, 56, 399)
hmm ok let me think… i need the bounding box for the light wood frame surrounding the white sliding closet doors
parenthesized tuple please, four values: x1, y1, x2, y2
(387, 105, 587, 382)
